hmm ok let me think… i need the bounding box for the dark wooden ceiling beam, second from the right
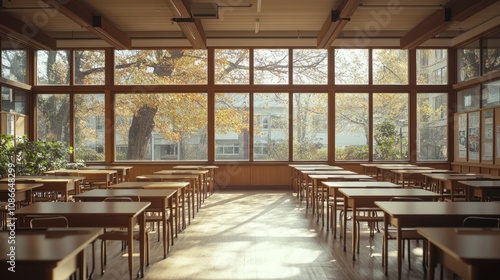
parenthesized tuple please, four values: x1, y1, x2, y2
(317, 0, 361, 48)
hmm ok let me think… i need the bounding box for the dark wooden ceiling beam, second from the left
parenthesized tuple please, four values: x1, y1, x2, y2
(43, 0, 132, 49)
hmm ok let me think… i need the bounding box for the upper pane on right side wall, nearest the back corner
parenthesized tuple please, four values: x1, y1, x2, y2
(457, 41, 481, 82)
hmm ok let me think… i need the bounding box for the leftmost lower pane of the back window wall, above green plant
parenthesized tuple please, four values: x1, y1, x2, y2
(36, 94, 70, 145)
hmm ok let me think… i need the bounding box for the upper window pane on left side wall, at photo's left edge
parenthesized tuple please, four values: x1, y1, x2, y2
(2, 49, 28, 83)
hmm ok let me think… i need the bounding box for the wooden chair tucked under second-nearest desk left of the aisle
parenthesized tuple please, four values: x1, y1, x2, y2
(98, 196, 150, 274)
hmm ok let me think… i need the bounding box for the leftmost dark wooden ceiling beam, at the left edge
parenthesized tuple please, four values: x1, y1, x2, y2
(0, 11, 57, 50)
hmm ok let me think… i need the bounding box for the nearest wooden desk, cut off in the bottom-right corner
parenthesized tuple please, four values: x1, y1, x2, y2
(417, 228, 500, 280)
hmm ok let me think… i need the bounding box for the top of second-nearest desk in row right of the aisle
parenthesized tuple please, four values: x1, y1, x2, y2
(375, 201, 500, 217)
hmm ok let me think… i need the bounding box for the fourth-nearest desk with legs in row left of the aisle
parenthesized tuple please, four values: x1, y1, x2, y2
(109, 181, 190, 231)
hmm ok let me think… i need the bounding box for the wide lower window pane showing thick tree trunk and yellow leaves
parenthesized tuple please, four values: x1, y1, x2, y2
(115, 93, 208, 161)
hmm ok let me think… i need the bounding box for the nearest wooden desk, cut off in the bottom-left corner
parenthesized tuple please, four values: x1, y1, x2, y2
(0, 228, 101, 280)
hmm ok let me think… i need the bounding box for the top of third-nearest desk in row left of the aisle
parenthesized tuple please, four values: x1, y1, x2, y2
(73, 189, 177, 200)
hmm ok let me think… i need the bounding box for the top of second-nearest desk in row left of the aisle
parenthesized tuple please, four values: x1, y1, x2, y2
(16, 202, 150, 217)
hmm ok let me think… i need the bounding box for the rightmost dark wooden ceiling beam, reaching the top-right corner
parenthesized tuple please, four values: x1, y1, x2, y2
(400, 0, 498, 49)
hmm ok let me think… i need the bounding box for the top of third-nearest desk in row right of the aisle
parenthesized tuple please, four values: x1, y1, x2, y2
(339, 188, 441, 198)
